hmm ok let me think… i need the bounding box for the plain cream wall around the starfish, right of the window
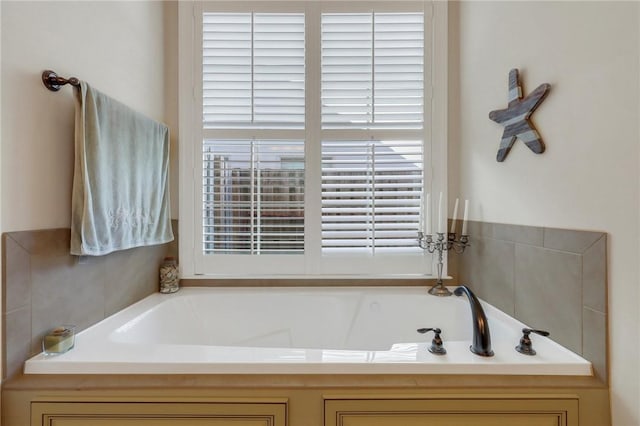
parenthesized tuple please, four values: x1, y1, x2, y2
(450, 1, 640, 426)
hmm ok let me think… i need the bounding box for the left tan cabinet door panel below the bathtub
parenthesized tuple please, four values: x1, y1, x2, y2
(31, 402, 286, 426)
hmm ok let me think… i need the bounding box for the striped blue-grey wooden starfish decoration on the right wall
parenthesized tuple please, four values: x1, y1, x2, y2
(489, 68, 551, 162)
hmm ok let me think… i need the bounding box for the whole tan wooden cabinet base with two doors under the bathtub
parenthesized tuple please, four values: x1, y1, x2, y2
(8, 375, 611, 426)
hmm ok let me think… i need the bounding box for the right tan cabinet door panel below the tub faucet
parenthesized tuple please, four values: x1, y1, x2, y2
(325, 395, 578, 426)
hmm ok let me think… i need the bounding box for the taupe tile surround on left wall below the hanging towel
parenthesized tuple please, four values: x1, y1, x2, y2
(2, 221, 177, 379)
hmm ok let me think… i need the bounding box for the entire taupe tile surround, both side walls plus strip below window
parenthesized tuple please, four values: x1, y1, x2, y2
(2, 221, 608, 383)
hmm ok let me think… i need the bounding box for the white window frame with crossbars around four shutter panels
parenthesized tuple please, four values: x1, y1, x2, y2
(178, 0, 448, 279)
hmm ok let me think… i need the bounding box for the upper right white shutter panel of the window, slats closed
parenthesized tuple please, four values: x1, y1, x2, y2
(322, 13, 424, 129)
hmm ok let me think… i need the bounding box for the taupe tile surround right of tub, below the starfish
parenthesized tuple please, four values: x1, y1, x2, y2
(451, 222, 608, 383)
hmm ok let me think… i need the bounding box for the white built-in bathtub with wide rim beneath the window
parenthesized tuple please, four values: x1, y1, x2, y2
(25, 287, 592, 376)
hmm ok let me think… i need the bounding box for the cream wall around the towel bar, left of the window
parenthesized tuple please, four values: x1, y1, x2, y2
(0, 1, 170, 232)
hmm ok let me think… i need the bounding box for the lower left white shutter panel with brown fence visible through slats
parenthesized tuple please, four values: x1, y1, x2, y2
(203, 140, 304, 254)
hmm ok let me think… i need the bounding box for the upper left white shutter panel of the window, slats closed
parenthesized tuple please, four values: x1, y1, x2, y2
(202, 13, 305, 128)
